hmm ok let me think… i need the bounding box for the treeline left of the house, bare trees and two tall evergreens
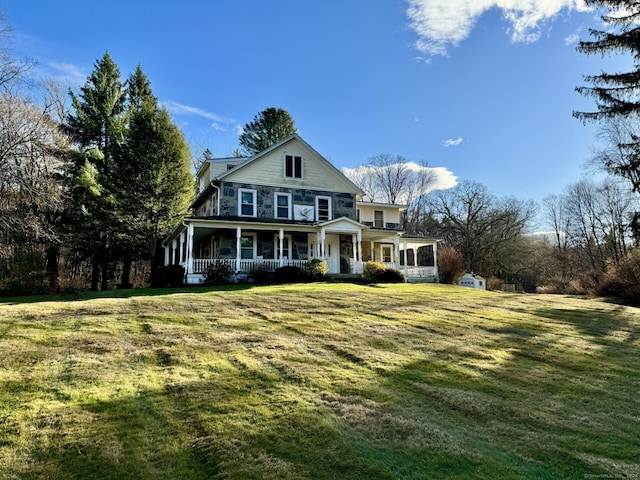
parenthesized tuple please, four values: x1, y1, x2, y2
(0, 24, 194, 294)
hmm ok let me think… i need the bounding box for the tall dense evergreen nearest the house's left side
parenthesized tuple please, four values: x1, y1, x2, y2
(117, 66, 194, 284)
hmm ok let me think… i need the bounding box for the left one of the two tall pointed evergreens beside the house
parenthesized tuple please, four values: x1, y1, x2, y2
(64, 53, 127, 290)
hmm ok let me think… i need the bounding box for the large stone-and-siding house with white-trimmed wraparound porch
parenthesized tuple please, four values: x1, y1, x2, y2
(163, 135, 438, 284)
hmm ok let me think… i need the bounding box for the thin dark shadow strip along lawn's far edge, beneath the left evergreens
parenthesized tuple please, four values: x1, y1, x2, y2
(0, 283, 257, 305)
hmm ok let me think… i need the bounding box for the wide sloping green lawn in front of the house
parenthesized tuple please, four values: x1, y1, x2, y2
(0, 284, 640, 480)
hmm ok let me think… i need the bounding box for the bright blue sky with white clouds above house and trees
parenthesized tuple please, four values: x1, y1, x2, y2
(0, 0, 624, 206)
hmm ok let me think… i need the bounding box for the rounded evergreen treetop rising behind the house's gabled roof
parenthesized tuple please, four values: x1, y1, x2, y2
(240, 107, 298, 155)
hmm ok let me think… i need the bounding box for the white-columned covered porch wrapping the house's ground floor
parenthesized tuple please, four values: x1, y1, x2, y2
(164, 218, 437, 284)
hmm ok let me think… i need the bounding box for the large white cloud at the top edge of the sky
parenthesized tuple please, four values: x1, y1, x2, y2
(407, 0, 589, 55)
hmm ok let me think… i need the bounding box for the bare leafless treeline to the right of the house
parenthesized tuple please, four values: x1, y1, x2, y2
(345, 154, 640, 301)
